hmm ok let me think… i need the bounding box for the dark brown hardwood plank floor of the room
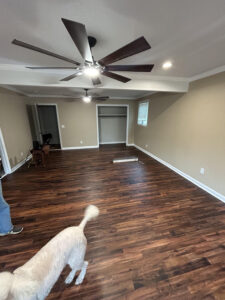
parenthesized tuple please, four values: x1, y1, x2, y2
(0, 146, 225, 300)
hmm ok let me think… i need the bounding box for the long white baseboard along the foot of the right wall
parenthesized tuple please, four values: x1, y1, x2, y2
(134, 145, 225, 202)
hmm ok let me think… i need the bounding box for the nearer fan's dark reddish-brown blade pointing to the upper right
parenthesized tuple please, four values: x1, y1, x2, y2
(98, 36, 151, 65)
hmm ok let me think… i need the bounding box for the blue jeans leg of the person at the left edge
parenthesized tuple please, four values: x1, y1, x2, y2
(0, 179, 13, 233)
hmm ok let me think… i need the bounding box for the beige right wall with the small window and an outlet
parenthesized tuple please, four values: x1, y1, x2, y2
(134, 73, 225, 195)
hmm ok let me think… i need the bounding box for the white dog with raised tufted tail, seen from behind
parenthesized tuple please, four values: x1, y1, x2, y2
(0, 205, 99, 300)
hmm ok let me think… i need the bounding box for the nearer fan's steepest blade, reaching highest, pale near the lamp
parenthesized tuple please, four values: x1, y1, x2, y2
(62, 18, 93, 63)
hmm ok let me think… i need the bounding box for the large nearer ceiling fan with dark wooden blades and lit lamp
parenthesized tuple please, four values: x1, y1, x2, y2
(12, 18, 154, 85)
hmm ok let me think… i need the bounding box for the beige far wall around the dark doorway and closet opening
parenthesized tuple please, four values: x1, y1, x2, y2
(30, 98, 135, 148)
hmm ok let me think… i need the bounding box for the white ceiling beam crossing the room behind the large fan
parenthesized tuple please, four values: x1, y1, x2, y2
(0, 66, 189, 93)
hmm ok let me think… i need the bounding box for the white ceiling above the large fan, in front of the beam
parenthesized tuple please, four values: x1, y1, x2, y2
(0, 0, 225, 96)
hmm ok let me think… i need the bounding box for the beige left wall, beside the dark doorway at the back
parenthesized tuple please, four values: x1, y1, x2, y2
(0, 88, 32, 167)
